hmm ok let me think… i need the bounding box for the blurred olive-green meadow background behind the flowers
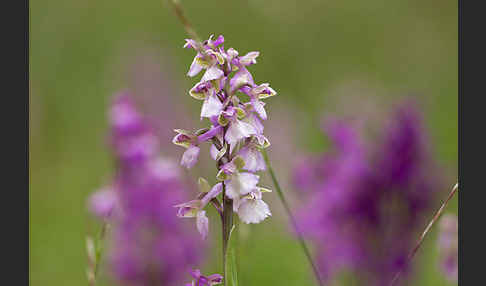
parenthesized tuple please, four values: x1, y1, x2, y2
(30, 0, 458, 286)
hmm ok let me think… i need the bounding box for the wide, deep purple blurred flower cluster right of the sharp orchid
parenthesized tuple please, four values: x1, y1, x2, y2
(294, 102, 440, 285)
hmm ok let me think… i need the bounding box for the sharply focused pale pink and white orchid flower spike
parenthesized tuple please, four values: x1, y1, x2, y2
(173, 36, 277, 238)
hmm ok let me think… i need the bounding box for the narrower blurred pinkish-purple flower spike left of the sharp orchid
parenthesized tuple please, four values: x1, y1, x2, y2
(90, 92, 203, 285)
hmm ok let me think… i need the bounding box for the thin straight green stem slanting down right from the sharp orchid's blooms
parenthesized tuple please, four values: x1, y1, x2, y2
(262, 149, 324, 286)
